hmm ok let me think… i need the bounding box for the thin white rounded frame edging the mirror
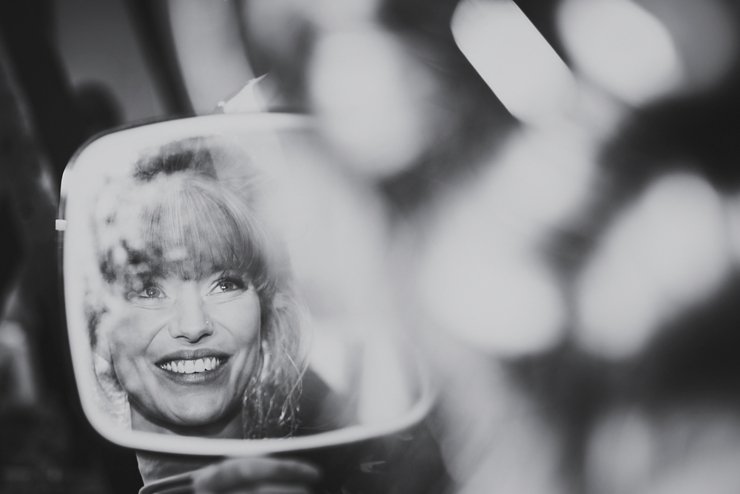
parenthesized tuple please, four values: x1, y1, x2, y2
(56, 113, 436, 456)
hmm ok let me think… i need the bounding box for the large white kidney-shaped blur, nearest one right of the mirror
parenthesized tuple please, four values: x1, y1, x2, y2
(418, 125, 595, 356)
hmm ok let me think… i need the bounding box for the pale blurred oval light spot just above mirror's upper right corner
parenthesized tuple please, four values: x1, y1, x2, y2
(309, 29, 438, 177)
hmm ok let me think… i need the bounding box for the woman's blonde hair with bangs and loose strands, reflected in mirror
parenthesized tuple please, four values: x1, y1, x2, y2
(89, 138, 306, 438)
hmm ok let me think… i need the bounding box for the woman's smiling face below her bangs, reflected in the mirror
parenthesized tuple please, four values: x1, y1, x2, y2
(102, 271, 261, 427)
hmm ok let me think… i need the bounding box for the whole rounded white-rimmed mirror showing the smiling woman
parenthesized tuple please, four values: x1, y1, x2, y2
(57, 114, 430, 455)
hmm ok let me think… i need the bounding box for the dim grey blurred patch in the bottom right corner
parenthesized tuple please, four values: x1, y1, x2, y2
(586, 407, 740, 494)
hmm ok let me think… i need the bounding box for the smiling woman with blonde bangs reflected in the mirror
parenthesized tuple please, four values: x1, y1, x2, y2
(90, 140, 328, 438)
